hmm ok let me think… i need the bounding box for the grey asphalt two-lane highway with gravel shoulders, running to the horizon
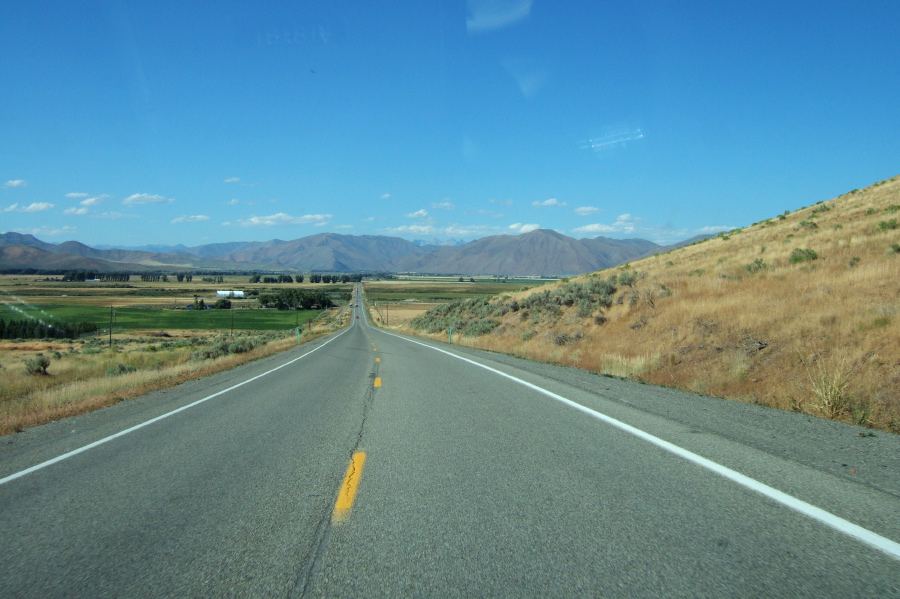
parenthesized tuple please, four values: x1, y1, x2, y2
(0, 290, 900, 598)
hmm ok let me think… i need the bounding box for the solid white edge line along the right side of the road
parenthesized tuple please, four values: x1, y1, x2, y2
(378, 329, 900, 560)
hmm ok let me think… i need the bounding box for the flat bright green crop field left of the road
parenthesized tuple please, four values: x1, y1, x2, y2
(0, 304, 321, 331)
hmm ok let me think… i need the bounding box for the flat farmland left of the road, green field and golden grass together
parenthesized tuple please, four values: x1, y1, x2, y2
(0, 275, 351, 434)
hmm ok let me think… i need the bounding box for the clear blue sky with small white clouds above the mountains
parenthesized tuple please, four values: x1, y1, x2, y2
(0, 0, 900, 246)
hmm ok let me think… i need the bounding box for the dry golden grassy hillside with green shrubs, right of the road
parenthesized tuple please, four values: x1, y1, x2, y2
(400, 176, 900, 432)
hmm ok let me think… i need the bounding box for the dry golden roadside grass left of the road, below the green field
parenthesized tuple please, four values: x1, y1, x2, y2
(0, 310, 349, 435)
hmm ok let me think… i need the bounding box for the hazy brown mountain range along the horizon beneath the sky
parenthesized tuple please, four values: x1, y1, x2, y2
(0, 229, 699, 276)
